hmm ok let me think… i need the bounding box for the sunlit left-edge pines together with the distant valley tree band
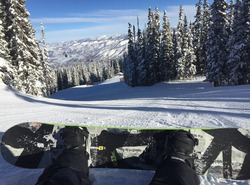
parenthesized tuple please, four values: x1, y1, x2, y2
(0, 0, 122, 96)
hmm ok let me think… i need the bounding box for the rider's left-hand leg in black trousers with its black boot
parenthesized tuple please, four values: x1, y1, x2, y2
(36, 126, 90, 185)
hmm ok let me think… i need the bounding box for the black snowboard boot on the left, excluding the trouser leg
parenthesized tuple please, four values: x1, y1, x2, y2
(62, 126, 89, 149)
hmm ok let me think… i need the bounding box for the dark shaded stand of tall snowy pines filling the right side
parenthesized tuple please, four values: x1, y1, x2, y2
(124, 0, 250, 86)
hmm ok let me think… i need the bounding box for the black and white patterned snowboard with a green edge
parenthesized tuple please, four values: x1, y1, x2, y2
(1, 122, 250, 180)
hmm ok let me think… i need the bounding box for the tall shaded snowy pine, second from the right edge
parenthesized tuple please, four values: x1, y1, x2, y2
(206, 0, 228, 86)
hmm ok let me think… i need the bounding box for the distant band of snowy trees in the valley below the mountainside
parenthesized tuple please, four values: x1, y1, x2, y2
(53, 58, 123, 91)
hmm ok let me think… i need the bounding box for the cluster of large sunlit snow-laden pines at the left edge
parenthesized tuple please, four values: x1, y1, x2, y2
(0, 0, 53, 96)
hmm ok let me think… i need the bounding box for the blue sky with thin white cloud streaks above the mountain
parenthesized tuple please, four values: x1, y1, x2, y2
(26, 0, 205, 43)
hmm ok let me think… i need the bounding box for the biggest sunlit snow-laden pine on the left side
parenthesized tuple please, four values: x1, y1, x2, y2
(3, 0, 45, 95)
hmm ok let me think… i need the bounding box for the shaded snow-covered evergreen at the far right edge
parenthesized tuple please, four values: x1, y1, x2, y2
(227, 0, 250, 85)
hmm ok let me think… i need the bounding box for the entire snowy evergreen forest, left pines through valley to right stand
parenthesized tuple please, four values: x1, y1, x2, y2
(0, 0, 250, 96)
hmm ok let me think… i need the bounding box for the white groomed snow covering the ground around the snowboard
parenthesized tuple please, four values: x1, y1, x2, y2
(0, 76, 250, 185)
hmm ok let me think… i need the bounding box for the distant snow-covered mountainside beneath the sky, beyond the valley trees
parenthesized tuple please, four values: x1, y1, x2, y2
(48, 35, 128, 65)
